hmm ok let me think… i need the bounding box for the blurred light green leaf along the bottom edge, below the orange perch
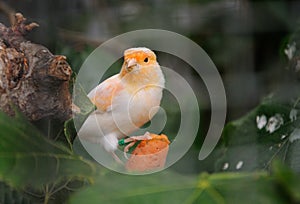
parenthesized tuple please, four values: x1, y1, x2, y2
(70, 171, 285, 204)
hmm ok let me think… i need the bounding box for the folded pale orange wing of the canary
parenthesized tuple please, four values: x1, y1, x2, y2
(88, 75, 123, 112)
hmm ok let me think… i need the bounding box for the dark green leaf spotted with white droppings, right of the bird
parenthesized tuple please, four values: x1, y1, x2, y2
(215, 97, 300, 172)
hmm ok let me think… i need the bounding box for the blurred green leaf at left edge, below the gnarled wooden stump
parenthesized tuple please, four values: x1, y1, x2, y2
(0, 113, 96, 188)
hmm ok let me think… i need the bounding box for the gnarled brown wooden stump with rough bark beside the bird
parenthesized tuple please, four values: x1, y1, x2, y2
(0, 13, 72, 120)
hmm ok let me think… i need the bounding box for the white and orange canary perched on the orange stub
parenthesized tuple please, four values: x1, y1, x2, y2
(78, 47, 165, 161)
